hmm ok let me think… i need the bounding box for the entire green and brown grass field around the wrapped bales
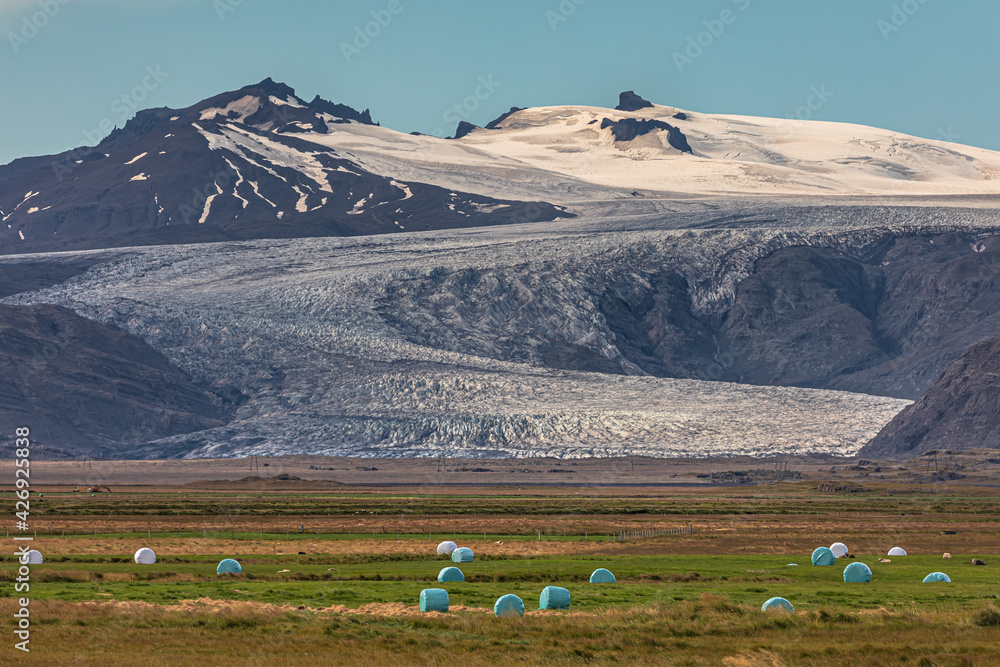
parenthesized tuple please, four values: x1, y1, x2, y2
(0, 483, 1000, 666)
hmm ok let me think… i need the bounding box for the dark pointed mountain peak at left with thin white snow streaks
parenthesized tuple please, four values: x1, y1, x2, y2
(0, 79, 568, 252)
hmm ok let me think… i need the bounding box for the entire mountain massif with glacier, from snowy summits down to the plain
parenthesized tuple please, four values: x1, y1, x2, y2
(0, 80, 1000, 457)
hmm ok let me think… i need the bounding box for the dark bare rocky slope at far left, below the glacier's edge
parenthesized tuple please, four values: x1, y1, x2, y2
(0, 305, 239, 457)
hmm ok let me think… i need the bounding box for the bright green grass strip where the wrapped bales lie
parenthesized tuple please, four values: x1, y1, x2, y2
(0, 554, 1000, 610)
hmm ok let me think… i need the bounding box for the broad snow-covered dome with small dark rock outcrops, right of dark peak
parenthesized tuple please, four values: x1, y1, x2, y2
(272, 92, 1000, 202)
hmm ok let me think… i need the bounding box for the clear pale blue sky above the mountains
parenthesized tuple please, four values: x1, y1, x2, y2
(0, 0, 1000, 164)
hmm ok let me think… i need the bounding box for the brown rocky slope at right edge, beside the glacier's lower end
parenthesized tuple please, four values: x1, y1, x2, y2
(861, 338, 1000, 458)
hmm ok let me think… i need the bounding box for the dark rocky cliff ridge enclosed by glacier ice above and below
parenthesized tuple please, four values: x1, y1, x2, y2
(380, 233, 1000, 399)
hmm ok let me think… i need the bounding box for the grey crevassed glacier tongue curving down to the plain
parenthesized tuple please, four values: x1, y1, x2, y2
(4, 205, 944, 457)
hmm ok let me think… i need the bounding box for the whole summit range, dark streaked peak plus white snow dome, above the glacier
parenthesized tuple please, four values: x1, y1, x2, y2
(7, 79, 1000, 252)
